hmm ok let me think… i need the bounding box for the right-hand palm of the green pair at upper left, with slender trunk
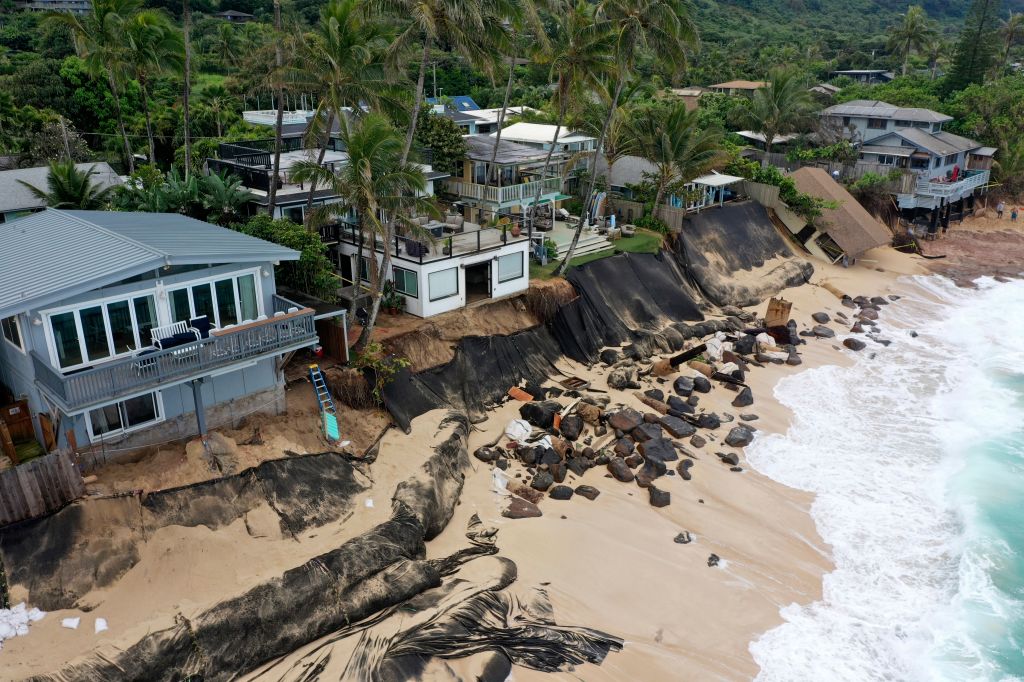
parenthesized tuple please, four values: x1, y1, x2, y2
(127, 10, 184, 164)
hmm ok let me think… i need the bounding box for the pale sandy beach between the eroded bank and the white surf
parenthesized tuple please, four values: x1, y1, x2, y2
(0, 237, 937, 680)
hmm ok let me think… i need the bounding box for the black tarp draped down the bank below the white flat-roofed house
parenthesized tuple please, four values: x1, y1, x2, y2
(384, 252, 703, 431)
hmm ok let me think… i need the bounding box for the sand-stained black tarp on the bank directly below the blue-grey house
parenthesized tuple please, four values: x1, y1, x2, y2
(0, 453, 366, 610)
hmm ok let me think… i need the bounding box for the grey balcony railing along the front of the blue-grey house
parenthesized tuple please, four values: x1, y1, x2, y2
(32, 307, 317, 411)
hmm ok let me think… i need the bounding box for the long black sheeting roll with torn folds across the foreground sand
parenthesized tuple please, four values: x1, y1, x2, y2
(32, 416, 623, 682)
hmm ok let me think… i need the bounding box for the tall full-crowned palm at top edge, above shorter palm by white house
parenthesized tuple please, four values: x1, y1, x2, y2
(296, 0, 400, 226)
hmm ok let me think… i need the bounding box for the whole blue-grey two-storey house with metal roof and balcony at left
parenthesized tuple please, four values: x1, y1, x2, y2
(0, 209, 317, 451)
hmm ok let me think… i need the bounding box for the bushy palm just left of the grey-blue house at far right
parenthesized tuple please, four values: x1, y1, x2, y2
(731, 69, 814, 163)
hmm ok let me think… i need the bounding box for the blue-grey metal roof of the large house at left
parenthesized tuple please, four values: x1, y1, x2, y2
(0, 209, 299, 317)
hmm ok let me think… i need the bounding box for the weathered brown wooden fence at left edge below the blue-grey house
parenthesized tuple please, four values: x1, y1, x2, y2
(0, 453, 85, 526)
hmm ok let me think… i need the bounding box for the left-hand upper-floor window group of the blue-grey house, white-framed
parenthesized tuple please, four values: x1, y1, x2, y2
(46, 295, 157, 370)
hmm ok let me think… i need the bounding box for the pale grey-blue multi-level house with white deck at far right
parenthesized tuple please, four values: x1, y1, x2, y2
(821, 99, 996, 210)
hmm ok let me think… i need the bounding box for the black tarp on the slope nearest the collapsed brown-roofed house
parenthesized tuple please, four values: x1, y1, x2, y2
(676, 201, 814, 307)
